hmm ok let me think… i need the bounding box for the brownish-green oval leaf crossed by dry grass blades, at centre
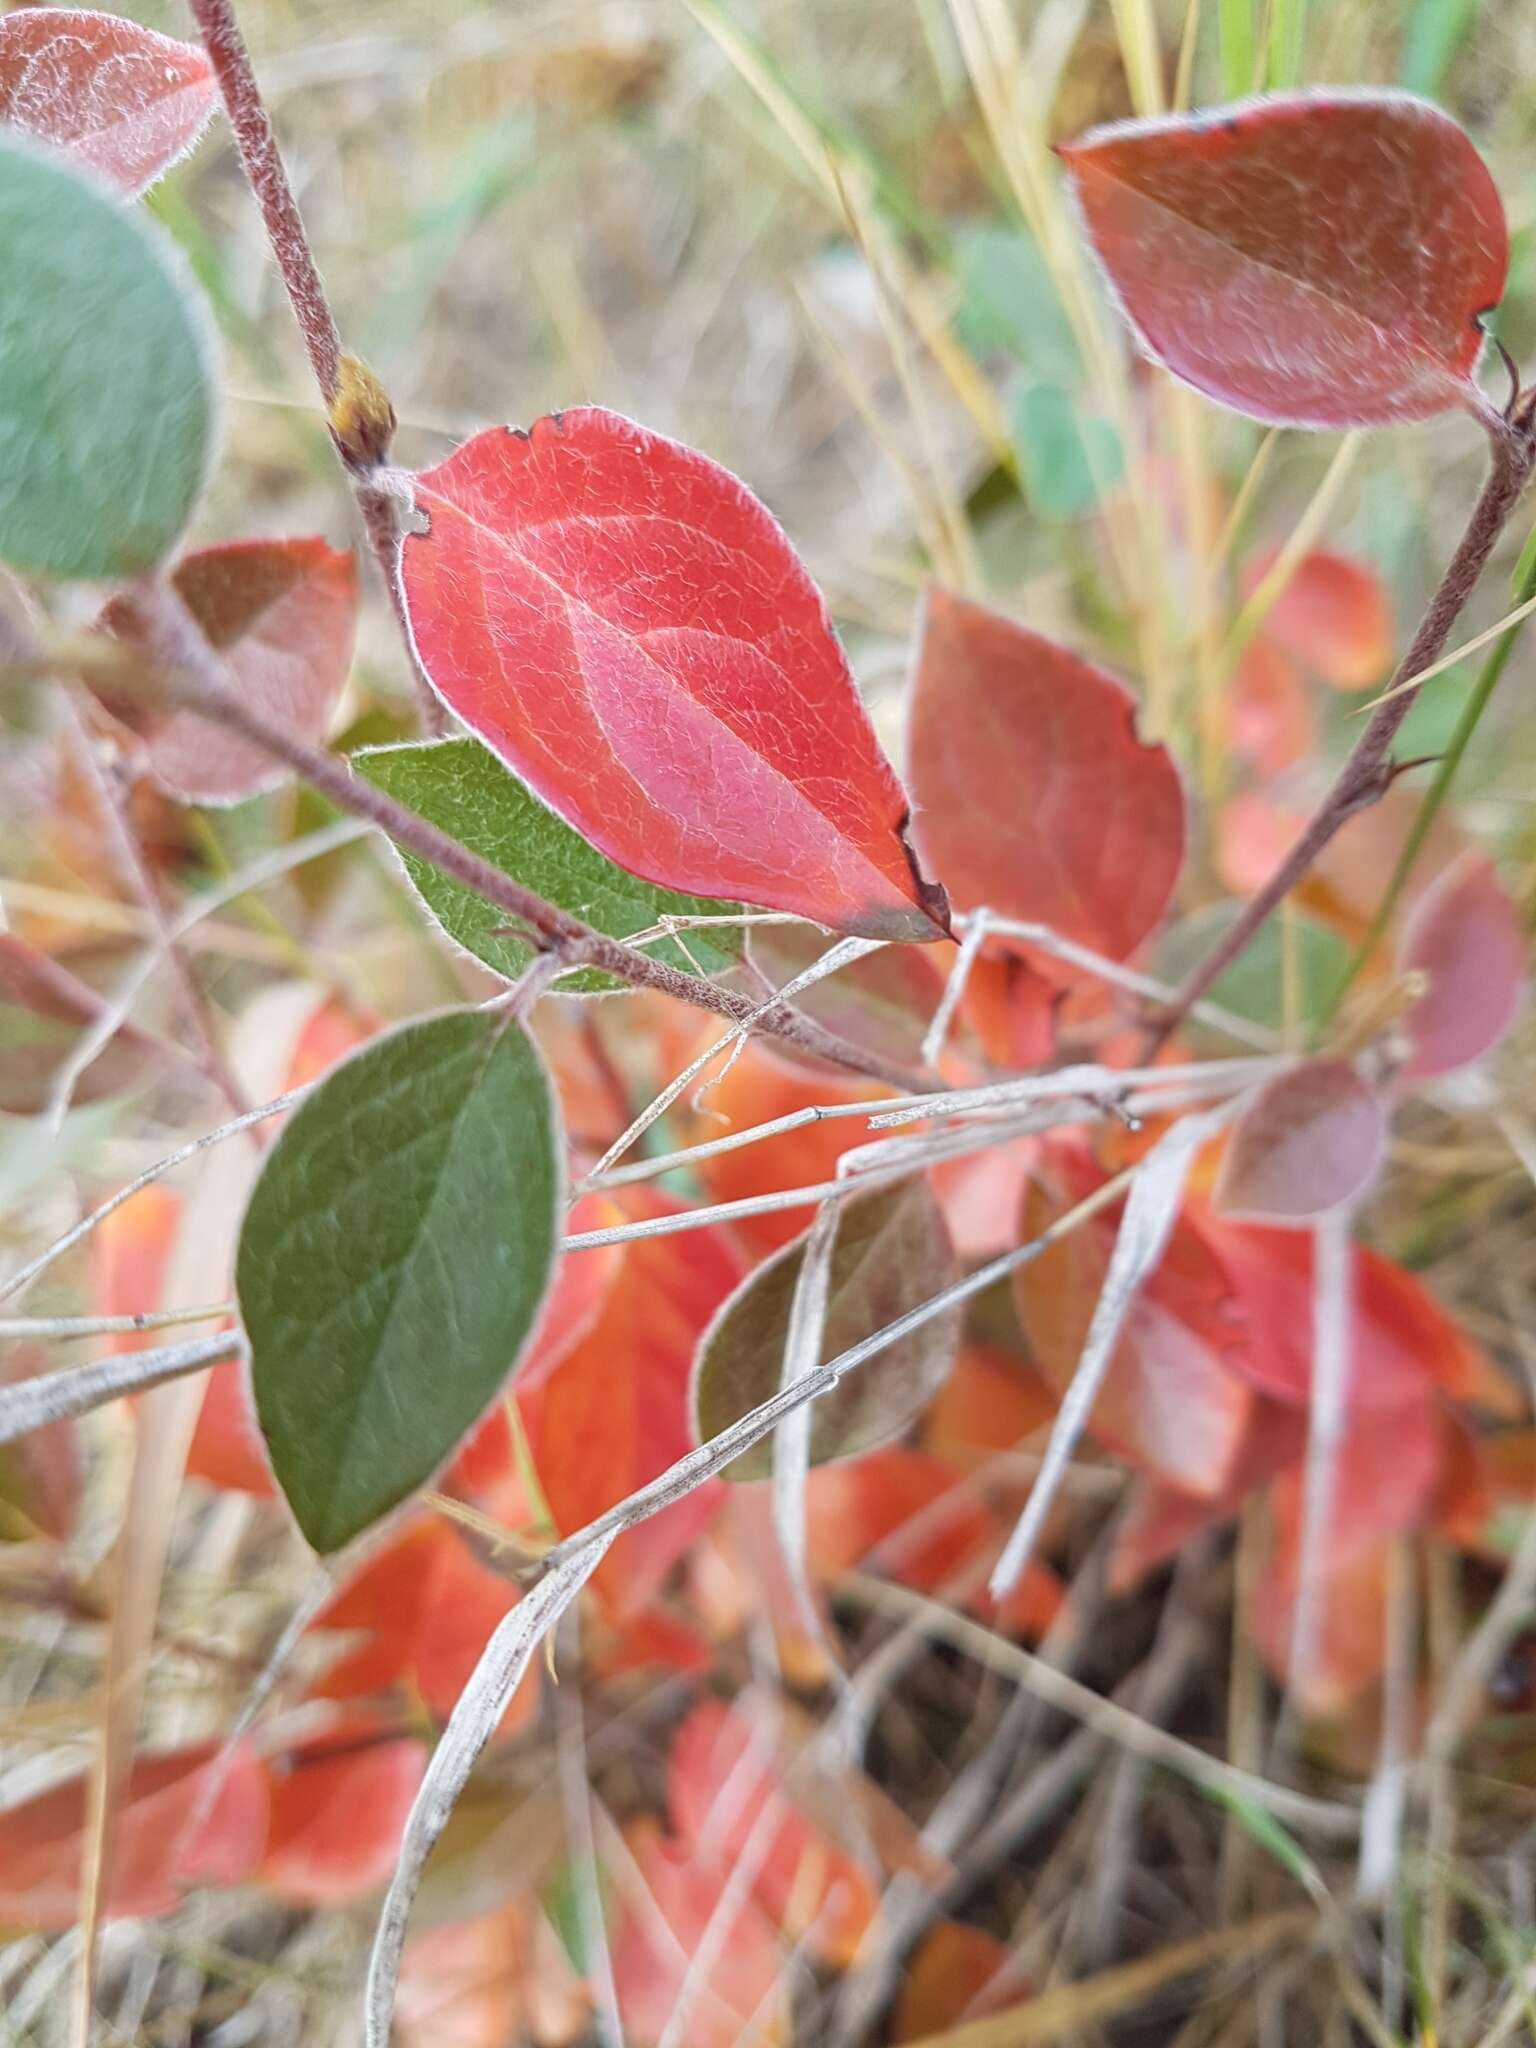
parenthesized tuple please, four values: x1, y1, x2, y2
(692, 1176, 963, 1479)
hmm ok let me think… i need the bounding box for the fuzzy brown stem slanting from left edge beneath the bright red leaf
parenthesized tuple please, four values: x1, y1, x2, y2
(129, 578, 936, 1094)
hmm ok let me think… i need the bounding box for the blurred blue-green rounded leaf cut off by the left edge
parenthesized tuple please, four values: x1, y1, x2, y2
(0, 135, 215, 578)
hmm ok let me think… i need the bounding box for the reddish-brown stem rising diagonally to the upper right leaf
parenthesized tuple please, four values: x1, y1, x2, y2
(1151, 393, 1536, 1044)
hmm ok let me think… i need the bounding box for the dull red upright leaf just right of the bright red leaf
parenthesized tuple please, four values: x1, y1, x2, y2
(909, 590, 1184, 961)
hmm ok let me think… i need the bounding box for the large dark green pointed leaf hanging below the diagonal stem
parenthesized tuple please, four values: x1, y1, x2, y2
(236, 1010, 565, 1552)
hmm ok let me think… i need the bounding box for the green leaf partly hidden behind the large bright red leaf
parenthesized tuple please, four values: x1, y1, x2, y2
(352, 739, 741, 995)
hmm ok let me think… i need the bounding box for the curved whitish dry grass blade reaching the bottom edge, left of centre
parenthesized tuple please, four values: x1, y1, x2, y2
(365, 1534, 612, 2048)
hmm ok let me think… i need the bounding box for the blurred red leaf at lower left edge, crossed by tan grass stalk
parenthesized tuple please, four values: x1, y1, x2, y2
(0, 1743, 266, 1929)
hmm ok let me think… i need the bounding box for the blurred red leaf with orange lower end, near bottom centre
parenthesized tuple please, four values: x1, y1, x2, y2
(668, 1700, 877, 1968)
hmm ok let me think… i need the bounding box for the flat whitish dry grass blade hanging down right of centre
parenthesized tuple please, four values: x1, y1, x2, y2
(989, 1104, 1235, 1599)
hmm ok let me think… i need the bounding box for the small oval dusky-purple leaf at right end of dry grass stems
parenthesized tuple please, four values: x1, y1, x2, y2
(1217, 1059, 1386, 1223)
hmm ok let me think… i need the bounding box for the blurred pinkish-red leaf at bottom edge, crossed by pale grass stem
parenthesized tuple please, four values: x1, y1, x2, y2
(612, 1823, 788, 2048)
